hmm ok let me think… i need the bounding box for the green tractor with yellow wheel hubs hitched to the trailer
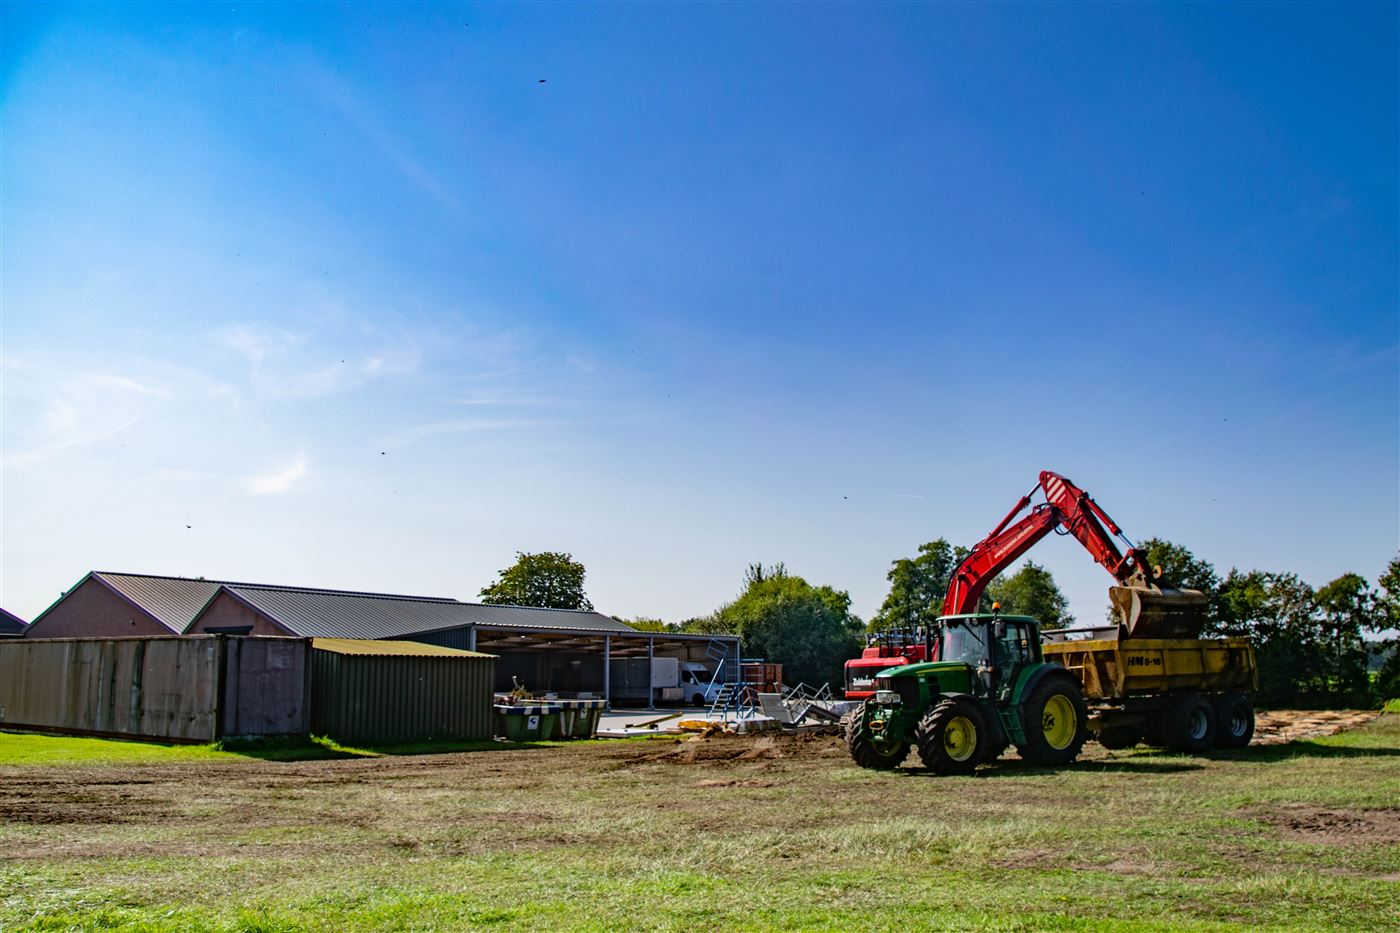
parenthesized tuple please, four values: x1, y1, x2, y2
(846, 615, 1089, 775)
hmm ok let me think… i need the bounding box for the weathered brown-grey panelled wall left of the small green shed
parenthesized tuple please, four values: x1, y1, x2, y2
(0, 636, 307, 742)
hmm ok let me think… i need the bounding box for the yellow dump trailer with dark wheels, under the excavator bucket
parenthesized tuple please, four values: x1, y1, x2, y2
(1042, 626, 1259, 752)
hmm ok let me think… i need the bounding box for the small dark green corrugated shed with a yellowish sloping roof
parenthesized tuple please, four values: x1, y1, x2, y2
(311, 639, 496, 742)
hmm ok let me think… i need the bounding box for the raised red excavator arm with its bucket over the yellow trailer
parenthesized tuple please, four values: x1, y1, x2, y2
(944, 471, 1205, 635)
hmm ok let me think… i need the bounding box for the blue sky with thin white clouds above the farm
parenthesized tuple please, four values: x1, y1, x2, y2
(0, 3, 1400, 621)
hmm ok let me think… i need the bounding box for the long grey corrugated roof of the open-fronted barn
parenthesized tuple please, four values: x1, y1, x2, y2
(228, 584, 636, 640)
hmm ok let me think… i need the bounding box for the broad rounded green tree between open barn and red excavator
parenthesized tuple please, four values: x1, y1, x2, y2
(713, 563, 861, 685)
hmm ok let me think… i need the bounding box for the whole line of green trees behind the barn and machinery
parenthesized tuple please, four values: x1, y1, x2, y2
(482, 538, 1400, 707)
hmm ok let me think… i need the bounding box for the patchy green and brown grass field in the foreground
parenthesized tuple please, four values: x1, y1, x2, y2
(0, 714, 1400, 930)
